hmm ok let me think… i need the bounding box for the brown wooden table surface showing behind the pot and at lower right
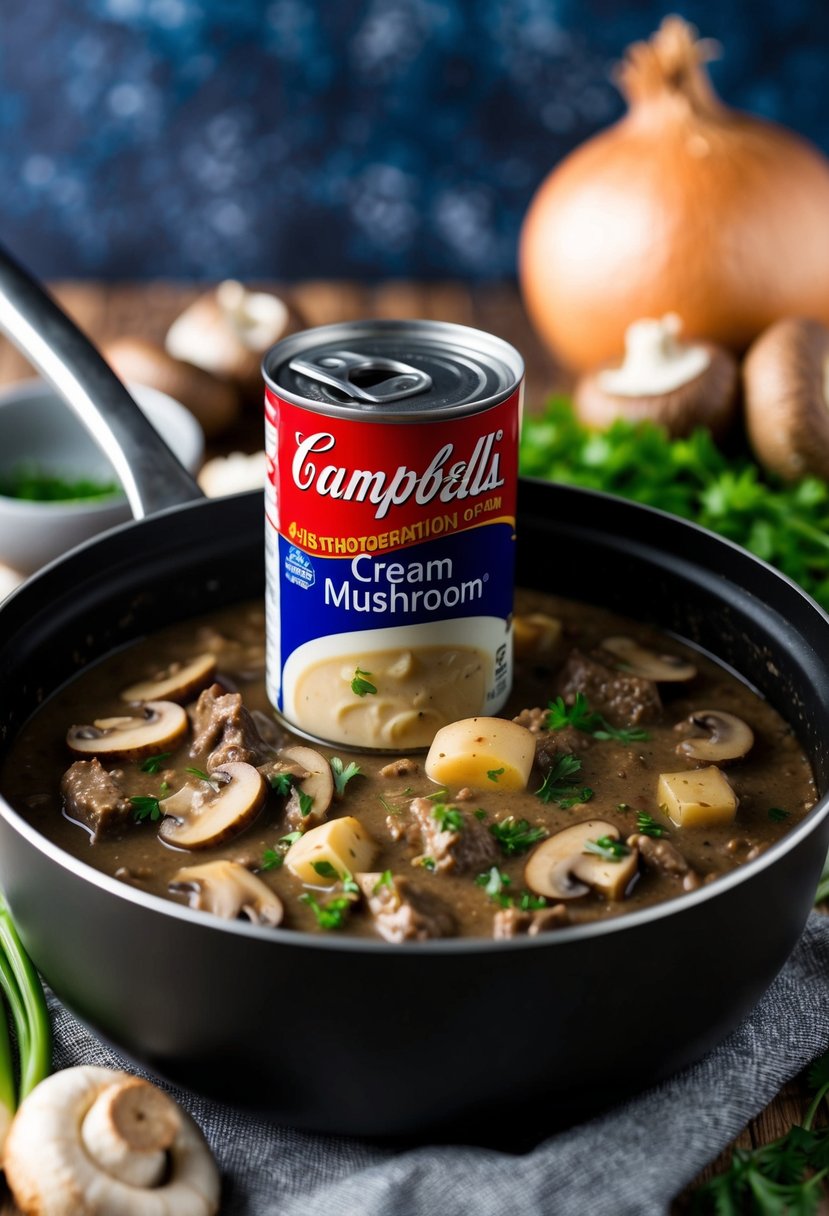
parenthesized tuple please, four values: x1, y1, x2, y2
(0, 281, 808, 1216)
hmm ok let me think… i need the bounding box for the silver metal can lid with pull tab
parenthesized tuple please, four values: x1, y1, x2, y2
(263, 320, 524, 422)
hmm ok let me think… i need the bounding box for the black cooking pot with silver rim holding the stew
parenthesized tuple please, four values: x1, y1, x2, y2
(0, 254, 829, 1138)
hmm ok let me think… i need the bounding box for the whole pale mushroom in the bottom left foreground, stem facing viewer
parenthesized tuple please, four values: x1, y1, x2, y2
(4, 1065, 220, 1216)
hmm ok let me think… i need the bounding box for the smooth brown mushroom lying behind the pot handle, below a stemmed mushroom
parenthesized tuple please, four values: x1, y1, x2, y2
(102, 337, 239, 439)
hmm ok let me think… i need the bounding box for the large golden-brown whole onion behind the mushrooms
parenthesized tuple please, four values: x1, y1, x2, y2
(519, 17, 829, 368)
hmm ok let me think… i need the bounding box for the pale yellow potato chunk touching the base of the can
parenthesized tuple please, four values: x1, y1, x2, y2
(425, 717, 535, 789)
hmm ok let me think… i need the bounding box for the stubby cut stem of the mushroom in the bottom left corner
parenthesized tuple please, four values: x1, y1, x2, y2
(80, 1076, 181, 1187)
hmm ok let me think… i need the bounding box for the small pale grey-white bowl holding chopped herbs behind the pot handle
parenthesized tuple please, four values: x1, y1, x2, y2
(0, 381, 204, 573)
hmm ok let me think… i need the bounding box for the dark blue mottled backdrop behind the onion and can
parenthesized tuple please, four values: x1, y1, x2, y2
(0, 0, 829, 277)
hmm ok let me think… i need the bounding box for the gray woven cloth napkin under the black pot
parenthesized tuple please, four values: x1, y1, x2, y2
(46, 914, 829, 1216)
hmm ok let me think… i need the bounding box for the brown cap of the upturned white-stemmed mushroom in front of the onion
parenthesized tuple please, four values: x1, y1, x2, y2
(573, 340, 739, 439)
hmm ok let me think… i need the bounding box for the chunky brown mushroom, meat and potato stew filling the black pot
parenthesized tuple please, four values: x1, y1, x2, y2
(2, 593, 816, 942)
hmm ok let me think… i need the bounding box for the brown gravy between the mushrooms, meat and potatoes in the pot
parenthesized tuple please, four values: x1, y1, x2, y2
(1, 592, 816, 936)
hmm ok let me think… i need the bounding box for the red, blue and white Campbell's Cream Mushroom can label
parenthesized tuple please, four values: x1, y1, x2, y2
(266, 374, 520, 749)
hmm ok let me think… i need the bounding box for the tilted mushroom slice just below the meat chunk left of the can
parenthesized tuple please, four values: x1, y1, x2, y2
(158, 761, 266, 849)
